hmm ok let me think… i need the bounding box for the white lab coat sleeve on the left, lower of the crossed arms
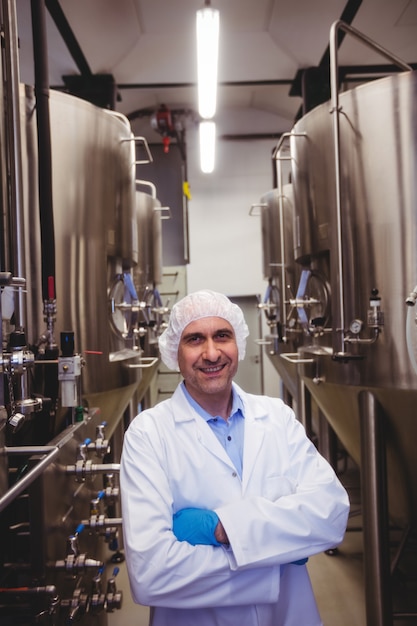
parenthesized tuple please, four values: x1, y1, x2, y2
(120, 416, 280, 608)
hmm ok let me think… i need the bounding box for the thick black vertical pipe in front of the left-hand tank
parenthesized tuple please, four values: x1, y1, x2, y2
(31, 0, 55, 302)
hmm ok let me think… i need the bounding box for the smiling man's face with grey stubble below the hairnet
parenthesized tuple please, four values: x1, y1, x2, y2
(178, 317, 238, 406)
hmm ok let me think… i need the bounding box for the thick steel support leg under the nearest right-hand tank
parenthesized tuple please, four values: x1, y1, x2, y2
(359, 391, 393, 626)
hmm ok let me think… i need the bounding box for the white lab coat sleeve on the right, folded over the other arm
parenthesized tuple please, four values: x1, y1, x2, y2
(216, 404, 349, 570)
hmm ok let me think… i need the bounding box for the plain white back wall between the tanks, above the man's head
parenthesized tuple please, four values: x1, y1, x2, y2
(187, 129, 275, 296)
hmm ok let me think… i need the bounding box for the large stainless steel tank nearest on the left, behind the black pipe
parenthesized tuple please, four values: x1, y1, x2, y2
(21, 86, 140, 419)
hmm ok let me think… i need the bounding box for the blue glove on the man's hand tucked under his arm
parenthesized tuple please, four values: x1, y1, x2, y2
(172, 508, 221, 546)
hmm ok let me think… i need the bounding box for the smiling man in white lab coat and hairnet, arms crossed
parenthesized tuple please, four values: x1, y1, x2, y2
(120, 291, 349, 626)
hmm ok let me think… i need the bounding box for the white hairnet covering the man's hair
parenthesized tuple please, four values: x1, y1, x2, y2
(159, 289, 249, 370)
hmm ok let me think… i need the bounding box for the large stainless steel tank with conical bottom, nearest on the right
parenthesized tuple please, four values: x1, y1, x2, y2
(284, 68, 417, 523)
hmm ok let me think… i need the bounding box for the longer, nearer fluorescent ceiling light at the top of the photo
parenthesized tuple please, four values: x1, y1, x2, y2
(197, 0, 219, 119)
